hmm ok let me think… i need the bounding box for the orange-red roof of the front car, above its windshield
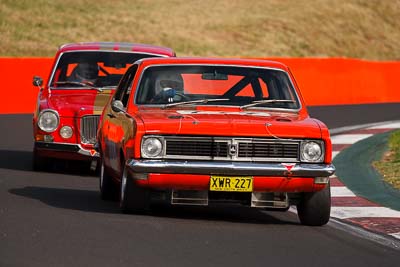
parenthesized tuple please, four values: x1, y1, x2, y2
(139, 57, 288, 71)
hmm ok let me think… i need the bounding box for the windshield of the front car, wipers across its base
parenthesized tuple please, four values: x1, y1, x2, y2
(135, 65, 300, 109)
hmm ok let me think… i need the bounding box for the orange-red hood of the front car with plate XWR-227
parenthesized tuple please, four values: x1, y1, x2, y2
(138, 109, 321, 138)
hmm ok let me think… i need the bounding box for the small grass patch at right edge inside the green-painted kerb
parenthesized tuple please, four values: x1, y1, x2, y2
(373, 130, 400, 190)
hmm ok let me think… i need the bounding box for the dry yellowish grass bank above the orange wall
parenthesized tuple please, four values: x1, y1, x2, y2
(0, 0, 400, 60)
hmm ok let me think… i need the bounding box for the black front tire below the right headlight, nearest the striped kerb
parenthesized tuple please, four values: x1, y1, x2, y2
(297, 183, 331, 226)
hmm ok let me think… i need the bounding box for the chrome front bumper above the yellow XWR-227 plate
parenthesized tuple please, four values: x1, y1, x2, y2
(126, 159, 335, 177)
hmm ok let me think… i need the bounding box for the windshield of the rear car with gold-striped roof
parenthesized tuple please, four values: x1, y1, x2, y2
(50, 51, 161, 89)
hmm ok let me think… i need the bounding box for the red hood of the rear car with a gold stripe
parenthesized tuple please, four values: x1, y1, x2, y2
(48, 90, 112, 117)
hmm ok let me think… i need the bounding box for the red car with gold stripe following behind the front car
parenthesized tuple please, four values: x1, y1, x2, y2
(33, 43, 175, 170)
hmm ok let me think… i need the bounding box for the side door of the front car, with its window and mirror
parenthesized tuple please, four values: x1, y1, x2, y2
(103, 64, 138, 177)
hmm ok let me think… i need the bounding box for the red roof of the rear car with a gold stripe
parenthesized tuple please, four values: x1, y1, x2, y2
(58, 42, 176, 56)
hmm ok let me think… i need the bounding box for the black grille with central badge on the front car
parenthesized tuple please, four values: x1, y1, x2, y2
(164, 137, 300, 162)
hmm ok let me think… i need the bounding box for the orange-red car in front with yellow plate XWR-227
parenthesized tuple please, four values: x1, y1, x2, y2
(98, 58, 335, 225)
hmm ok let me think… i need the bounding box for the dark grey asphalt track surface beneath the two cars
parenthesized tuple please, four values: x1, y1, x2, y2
(0, 104, 400, 267)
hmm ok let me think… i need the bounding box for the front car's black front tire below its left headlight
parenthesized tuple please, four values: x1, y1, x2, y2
(120, 166, 150, 214)
